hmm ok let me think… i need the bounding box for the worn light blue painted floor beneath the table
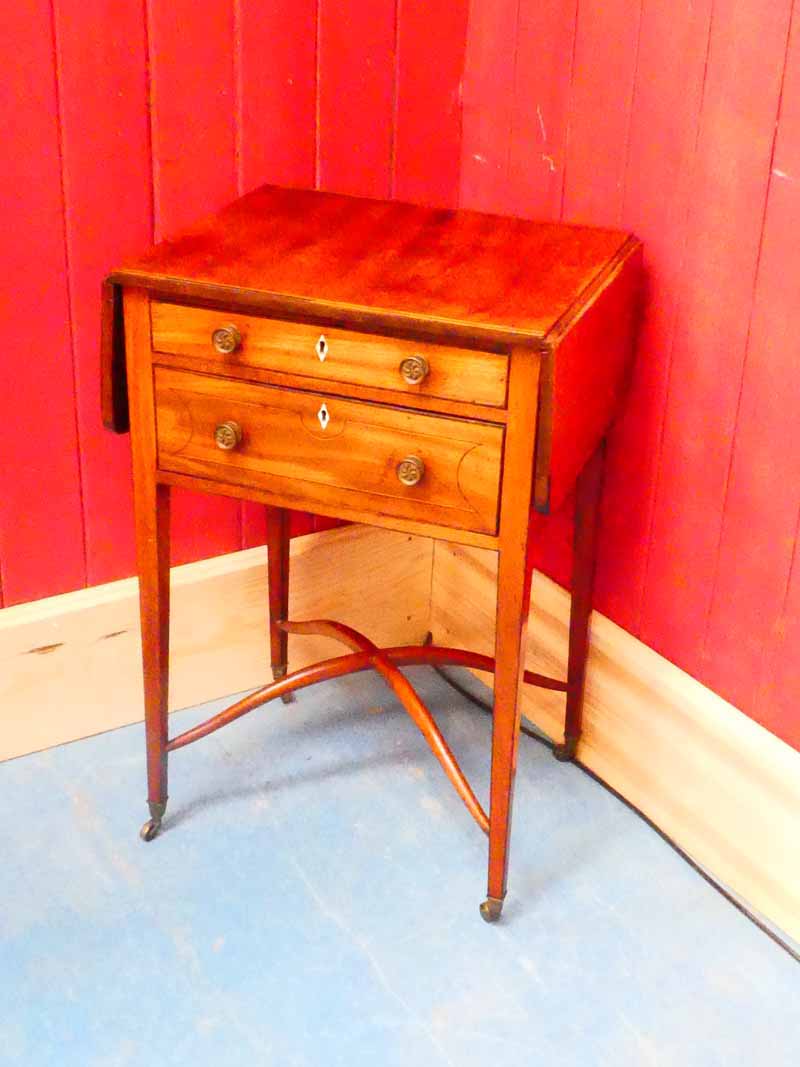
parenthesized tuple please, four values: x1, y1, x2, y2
(0, 668, 800, 1067)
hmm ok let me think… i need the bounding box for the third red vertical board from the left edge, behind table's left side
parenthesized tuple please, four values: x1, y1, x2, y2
(147, 0, 241, 563)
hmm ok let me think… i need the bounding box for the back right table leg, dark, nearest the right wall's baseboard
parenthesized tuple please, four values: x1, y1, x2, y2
(553, 445, 605, 762)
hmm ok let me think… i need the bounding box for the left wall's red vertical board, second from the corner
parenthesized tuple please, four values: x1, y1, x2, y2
(318, 0, 397, 196)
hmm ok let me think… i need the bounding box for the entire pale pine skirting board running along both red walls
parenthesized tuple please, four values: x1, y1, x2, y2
(0, 526, 800, 940)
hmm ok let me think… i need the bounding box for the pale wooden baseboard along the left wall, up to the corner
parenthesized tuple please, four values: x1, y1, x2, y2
(0, 526, 432, 760)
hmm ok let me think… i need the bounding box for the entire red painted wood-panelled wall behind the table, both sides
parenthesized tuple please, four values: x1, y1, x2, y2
(0, 0, 800, 748)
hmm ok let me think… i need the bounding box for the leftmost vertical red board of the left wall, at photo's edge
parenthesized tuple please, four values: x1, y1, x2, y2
(0, 0, 86, 605)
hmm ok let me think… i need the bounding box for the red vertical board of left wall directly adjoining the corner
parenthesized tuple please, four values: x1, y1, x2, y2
(393, 0, 467, 207)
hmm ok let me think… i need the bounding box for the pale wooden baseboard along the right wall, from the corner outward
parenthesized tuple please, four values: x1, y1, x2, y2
(431, 543, 800, 941)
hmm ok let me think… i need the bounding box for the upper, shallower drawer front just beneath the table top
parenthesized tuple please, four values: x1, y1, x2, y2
(150, 301, 508, 408)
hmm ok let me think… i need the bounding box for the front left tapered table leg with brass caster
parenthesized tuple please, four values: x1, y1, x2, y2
(135, 478, 170, 841)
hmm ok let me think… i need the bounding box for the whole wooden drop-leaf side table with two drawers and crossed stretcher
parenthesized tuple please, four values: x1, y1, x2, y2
(102, 187, 641, 922)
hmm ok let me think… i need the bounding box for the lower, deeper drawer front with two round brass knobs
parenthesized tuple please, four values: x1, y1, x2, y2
(156, 367, 503, 534)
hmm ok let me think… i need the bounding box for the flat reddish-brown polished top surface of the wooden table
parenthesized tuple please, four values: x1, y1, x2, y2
(111, 186, 631, 340)
